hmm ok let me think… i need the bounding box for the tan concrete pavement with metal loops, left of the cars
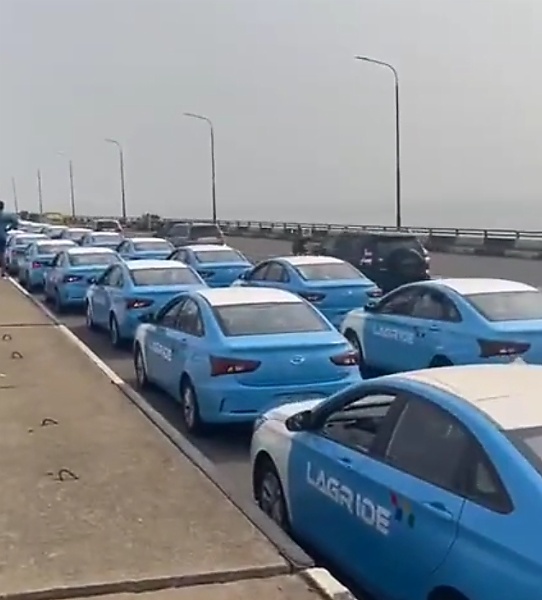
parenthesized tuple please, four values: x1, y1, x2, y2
(0, 280, 336, 600)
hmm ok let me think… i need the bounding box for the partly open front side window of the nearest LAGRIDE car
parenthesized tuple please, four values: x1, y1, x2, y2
(319, 393, 404, 454)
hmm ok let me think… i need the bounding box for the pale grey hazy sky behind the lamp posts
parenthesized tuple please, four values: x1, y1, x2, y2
(0, 0, 542, 229)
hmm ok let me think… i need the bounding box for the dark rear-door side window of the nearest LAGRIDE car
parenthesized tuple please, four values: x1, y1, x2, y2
(384, 398, 472, 495)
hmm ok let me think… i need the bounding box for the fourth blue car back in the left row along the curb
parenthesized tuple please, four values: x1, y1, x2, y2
(44, 246, 121, 313)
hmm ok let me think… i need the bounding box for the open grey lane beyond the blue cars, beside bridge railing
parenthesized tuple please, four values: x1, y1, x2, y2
(228, 237, 542, 287)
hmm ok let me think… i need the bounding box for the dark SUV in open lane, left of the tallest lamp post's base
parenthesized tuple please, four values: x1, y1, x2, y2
(315, 231, 430, 292)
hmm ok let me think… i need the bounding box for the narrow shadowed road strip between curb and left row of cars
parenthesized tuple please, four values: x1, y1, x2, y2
(31, 295, 252, 497)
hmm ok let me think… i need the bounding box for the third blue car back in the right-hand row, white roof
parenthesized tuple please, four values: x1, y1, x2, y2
(169, 244, 252, 287)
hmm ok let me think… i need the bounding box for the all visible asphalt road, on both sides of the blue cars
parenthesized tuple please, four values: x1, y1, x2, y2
(26, 238, 542, 494)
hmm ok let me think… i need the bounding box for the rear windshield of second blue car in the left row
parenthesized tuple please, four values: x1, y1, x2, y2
(214, 302, 329, 337)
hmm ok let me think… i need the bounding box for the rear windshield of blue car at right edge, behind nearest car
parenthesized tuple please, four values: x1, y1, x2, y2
(465, 290, 542, 321)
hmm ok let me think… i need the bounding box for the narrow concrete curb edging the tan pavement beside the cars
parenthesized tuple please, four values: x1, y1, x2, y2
(6, 278, 362, 600)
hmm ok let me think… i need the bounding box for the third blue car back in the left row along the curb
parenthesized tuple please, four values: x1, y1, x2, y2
(86, 259, 207, 347)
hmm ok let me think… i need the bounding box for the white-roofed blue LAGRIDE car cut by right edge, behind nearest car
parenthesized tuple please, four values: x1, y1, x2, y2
(341, 278, 542, 375)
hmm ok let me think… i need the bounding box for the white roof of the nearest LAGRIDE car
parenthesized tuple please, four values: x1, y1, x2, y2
(402, 363, 542, 430)
